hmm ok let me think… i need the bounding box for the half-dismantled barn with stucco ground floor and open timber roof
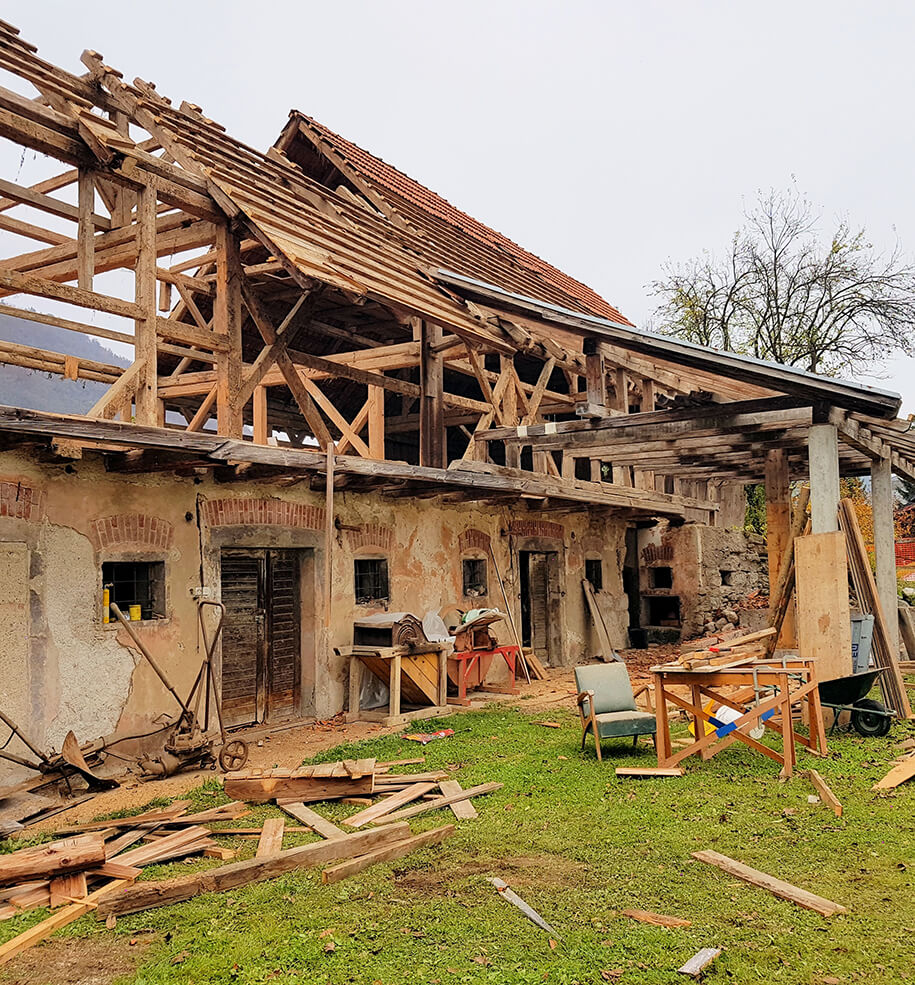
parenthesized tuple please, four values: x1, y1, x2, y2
(0, 15, 915, 968)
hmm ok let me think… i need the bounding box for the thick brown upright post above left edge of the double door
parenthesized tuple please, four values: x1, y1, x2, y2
(213, 225, 242, 438)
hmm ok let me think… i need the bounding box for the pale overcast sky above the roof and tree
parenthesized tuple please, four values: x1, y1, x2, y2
(3, 0, 915, 413)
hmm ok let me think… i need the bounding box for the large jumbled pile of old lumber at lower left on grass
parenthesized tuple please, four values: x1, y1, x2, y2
(0, 759, 502, 964)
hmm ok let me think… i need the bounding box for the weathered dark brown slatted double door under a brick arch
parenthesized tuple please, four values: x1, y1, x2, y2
(221, 549, 302, 725)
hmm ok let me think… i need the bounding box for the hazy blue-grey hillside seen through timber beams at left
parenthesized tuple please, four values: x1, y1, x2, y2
(0, 304, 129, 414)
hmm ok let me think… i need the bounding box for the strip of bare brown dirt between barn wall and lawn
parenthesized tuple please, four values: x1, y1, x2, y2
(23, 647, 676, 831)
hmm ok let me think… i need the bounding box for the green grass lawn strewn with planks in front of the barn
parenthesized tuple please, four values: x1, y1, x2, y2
(0, 707, 915, 985)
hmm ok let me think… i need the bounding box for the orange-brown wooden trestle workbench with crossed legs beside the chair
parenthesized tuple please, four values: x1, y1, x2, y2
(651, 659, 826, 776)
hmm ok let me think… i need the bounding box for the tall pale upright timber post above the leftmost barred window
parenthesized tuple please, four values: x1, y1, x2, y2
(134, 184, 159, 426)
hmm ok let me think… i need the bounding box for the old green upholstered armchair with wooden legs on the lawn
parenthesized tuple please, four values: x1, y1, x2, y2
(575, 663, 657, 759)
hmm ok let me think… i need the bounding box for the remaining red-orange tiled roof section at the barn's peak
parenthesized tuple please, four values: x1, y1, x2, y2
(290, 110, 632, 325)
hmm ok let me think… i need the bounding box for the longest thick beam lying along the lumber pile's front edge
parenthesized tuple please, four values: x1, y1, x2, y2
(96, 824, 410, 920)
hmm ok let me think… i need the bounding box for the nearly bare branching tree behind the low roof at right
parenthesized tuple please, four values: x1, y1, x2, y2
(651, 189, 915, 375)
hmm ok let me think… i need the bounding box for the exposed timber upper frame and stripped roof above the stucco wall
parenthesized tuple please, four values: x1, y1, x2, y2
(0, 22, 915, 644)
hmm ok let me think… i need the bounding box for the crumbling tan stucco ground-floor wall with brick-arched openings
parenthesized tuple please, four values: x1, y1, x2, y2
(0, 452, 627, 768)
